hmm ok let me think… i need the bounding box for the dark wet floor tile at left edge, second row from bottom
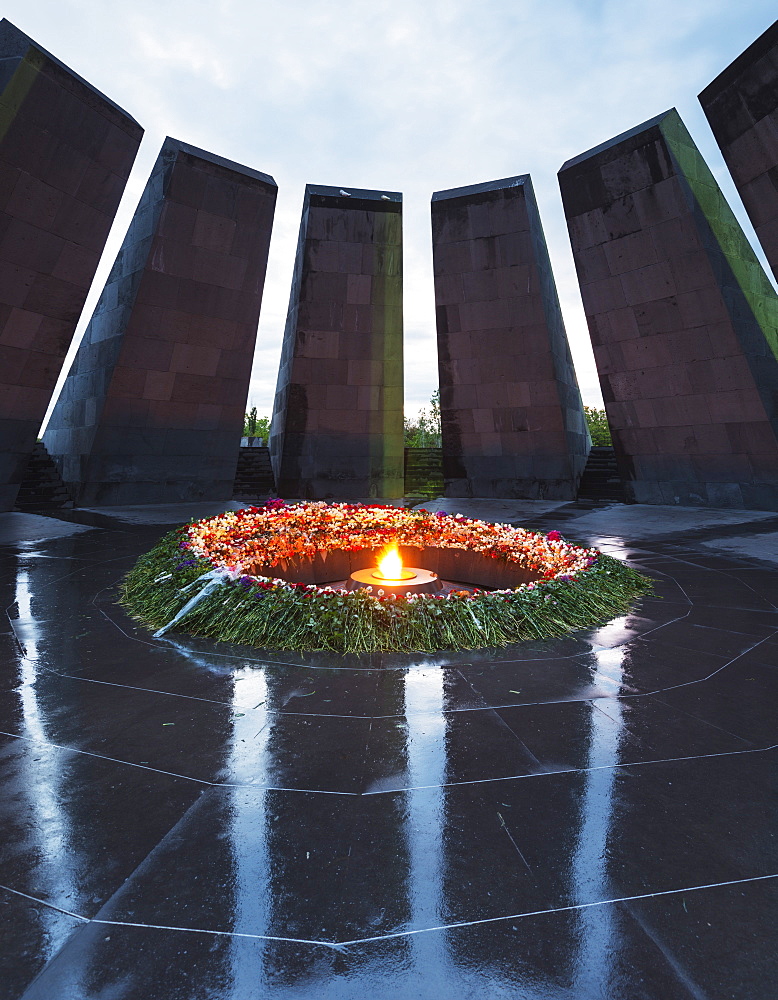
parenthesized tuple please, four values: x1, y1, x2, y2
(0, 732, 201, 916)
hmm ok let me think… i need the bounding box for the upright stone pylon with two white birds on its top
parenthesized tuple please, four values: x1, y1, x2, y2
(269, 185, 404, 499)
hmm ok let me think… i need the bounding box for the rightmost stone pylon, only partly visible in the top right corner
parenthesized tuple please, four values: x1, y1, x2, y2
(700, 21, 778, 278)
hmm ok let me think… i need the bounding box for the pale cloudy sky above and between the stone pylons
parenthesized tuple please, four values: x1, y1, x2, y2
(9, 0, 775, 424)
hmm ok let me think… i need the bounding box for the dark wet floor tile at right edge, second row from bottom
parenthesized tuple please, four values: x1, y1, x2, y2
(452, 752, 778, 915)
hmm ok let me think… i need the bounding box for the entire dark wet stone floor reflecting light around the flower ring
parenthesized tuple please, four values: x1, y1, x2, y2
(0, 501, 778, 1000)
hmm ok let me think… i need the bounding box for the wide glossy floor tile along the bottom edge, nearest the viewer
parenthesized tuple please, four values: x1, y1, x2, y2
(16, 905, 740, 1000)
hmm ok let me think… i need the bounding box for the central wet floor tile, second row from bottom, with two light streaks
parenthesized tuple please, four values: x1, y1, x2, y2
(89, 788, 545, 941)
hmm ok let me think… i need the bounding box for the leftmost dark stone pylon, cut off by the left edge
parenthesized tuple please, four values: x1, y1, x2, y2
(0, 20, 143, 510)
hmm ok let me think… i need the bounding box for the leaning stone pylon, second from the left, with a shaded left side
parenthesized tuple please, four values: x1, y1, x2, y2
(44, 138, 276, 505)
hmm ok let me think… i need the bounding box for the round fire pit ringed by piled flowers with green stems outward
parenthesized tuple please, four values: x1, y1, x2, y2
(121, 501, 650, 652)
